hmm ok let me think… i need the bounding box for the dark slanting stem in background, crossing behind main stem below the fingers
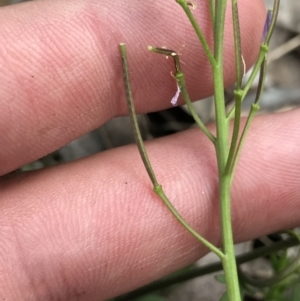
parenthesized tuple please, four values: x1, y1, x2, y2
(114, 237, 299, 301)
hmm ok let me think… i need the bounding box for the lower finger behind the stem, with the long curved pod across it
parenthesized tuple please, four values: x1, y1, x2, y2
(0, 110, 300, 300)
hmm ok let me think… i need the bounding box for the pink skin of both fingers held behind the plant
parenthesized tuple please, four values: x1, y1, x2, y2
(0, 0, 300, 300)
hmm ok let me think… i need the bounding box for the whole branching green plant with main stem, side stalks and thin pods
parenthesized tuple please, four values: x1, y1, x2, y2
(121, 0, 280, 301)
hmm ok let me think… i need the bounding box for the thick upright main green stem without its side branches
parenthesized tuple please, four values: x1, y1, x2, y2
(213, 0, 241, 301)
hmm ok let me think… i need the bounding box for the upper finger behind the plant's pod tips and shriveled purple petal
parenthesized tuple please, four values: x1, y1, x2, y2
(0, 0, 265, 174)
